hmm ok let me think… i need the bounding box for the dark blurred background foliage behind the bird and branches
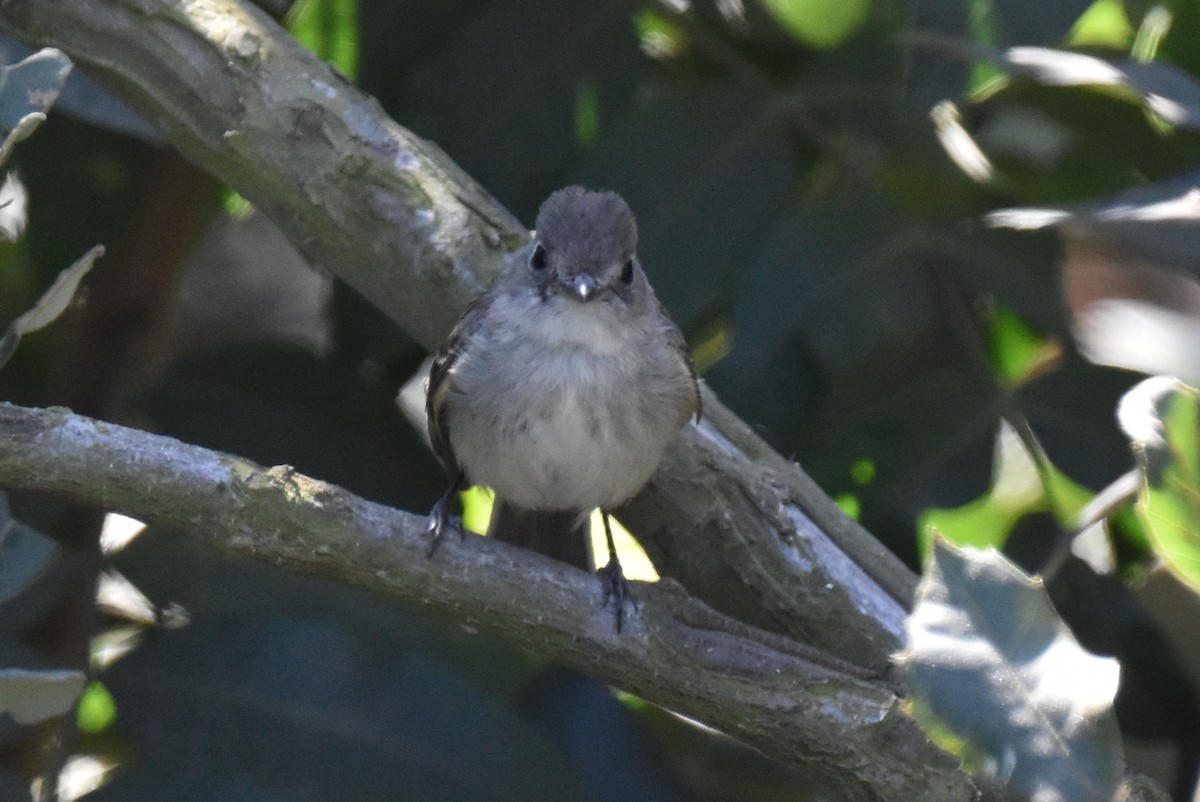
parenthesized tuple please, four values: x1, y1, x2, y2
(0, 0, 1200, 800)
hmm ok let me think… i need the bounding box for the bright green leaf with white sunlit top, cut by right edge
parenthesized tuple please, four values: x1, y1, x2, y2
(1117, 376, 1200, 591)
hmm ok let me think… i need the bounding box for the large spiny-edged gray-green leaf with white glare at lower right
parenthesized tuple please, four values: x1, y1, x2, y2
(900, 538, 1124, 802)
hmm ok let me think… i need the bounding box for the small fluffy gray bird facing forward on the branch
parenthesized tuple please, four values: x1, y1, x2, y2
(426, 186, 700, 630)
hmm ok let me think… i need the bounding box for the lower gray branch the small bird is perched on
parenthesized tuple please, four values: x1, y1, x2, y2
(0, 403, 973, 801)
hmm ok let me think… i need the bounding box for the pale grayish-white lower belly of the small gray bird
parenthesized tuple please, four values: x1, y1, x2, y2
(450, 365, 678, 510)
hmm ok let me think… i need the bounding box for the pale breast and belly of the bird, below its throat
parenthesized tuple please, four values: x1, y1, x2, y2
(446, 292, 691, 510)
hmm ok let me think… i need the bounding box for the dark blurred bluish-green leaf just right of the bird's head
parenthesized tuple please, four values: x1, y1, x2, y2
(578, 83, 799, 327)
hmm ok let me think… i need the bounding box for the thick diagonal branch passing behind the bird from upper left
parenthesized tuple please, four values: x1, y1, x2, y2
(0, 0, 914, 671)
